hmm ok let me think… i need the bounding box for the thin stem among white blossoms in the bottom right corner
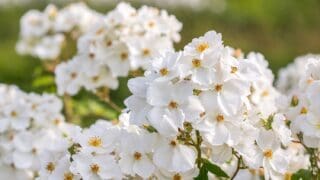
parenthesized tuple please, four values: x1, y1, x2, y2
(297, 133, 320, 180)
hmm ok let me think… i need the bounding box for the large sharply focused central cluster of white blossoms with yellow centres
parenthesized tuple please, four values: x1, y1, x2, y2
(125, 31, 306, 179)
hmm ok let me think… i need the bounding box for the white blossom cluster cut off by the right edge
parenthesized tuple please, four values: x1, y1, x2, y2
(278, 55, 320, 148)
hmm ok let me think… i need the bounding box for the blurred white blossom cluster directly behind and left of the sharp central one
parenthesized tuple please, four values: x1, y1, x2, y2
(55, 3, 182, 95)
